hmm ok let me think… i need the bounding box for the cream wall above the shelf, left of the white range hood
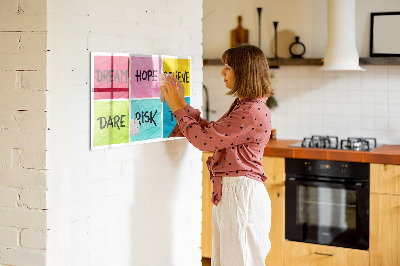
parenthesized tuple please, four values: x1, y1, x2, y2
(203, 0, 327, 58)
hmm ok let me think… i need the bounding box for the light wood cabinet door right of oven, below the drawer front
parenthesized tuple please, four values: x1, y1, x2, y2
(369, 193, 400, 266)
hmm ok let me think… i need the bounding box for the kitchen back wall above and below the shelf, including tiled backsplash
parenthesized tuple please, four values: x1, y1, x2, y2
(203, 0, 400, 144)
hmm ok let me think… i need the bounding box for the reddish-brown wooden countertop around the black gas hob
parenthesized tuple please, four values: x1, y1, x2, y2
(264, 140, 400, 164)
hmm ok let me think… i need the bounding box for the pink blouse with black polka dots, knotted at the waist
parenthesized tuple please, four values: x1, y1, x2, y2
(170, 97, 271, 205)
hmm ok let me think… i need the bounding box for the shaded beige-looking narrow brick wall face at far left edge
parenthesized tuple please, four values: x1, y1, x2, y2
(0, 0, 47, 265)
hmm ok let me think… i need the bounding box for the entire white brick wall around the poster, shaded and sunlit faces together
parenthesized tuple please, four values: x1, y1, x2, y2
(0, 0, 202, 266)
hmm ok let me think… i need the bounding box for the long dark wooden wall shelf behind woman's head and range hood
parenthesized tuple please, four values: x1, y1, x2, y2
(203, 57, 400, 68)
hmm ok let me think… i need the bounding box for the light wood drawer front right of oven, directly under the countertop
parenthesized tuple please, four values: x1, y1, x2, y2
(370, 163, 400, 195)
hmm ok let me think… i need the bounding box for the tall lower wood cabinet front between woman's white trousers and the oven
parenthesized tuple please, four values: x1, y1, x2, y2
(265, 184, 285, 266)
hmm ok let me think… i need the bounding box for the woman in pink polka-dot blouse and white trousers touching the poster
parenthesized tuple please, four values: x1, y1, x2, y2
(161, 45, 272, 266)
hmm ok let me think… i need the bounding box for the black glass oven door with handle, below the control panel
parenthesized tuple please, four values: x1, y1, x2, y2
(285, 176, 369, 250)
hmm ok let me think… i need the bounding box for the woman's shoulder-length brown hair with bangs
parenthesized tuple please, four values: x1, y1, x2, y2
(221, 44, 273, 99)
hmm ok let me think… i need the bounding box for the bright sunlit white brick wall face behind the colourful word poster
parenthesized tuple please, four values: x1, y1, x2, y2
(47, 0, 203, 266)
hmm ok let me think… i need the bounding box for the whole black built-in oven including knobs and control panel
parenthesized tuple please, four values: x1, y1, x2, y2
(285, 158, 369, 250)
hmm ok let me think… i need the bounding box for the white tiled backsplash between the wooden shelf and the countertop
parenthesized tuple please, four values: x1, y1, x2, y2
(203, 65, 400, 144)
